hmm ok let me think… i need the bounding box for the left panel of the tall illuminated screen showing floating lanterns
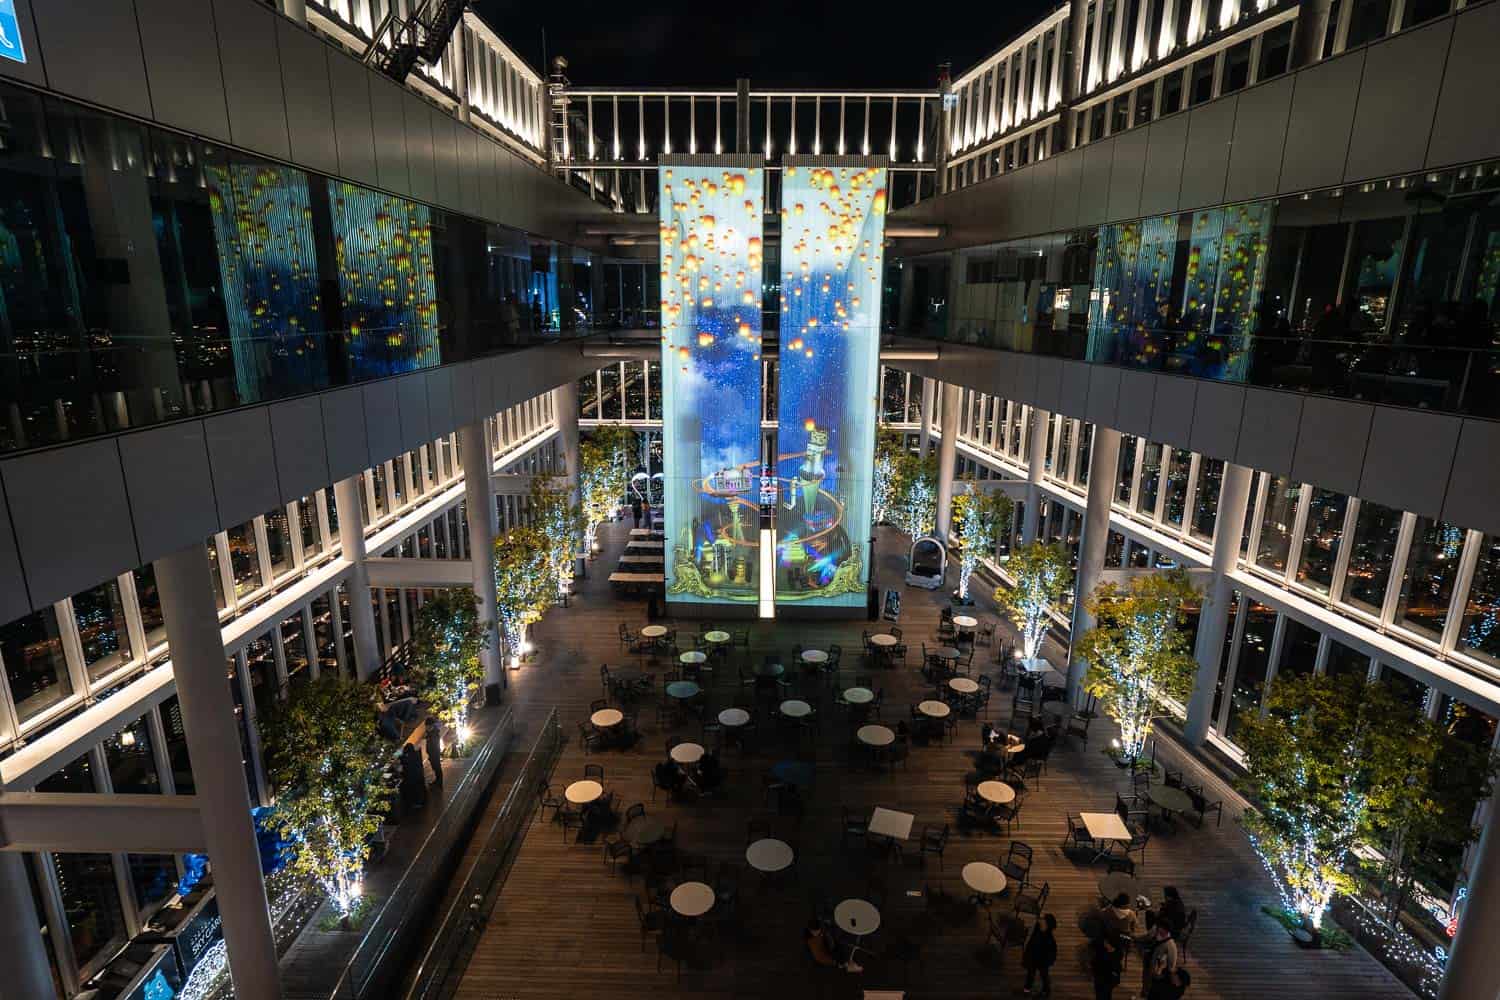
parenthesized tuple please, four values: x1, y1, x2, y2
(657, 156, 764, 603)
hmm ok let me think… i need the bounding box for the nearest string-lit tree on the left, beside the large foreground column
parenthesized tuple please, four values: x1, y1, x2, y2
(260, 673, 390, 927)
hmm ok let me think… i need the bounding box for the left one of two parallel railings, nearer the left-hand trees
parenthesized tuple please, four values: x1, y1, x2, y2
(329, 709, 516, 1000)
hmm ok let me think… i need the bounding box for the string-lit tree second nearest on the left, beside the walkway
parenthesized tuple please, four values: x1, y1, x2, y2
(410, 588, 489, 745)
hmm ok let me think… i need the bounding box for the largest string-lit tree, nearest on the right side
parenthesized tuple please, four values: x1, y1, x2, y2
(1235, 675, 1422, 939)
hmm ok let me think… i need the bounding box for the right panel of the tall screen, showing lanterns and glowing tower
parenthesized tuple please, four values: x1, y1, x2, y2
(776, 157, 887, 607)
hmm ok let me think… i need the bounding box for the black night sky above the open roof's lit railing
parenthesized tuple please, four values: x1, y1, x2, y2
(474, 0, 1058, 88)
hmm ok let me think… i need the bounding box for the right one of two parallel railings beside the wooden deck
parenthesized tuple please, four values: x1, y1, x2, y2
(407, 709, 563, 1000)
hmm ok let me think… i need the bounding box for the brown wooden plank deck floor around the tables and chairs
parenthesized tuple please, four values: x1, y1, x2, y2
(459, 526, 1410, 1000)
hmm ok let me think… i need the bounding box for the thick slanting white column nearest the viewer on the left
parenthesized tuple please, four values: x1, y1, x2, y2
(153, 544, 281, 1000)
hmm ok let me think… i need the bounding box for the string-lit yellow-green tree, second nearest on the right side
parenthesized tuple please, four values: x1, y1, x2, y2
(1077, 571, 1197, 765)
